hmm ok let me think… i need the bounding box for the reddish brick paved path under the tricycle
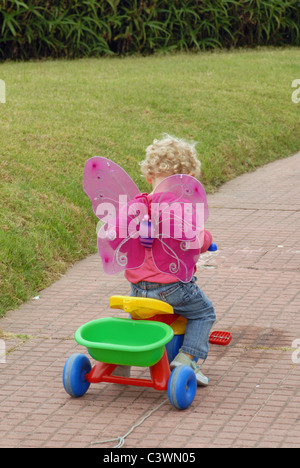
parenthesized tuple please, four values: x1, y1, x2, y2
(0, 153, 300, 448)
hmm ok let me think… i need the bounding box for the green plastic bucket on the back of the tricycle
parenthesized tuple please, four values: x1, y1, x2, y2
(75, 317, 174, 367)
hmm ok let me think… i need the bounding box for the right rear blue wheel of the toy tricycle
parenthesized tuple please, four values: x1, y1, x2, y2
(168, 366, 197, 409)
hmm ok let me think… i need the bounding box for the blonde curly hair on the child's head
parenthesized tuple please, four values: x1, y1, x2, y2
(140, 134, 201, 178)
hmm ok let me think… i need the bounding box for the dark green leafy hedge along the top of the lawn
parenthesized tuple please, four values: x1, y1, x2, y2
(0, 0, 300, 60)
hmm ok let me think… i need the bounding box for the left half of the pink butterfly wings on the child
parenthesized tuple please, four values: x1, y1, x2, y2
(83, 156, 145, 274)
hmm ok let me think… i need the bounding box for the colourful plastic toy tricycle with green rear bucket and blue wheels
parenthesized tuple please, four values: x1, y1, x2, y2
(63, 296, 231, 410)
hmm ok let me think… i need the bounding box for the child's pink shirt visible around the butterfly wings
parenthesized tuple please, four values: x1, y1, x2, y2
(125, 195, 212, 284)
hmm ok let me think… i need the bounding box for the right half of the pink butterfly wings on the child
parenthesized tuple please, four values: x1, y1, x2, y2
(151, 174, 209, 282)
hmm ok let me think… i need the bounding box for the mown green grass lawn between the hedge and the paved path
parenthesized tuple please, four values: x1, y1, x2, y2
(0, 49, 300, 315)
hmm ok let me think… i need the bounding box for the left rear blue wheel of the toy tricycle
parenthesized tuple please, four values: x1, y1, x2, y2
(63, 353, 92, 397)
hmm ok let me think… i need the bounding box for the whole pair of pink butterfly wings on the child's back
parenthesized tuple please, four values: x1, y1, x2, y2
(83, 156, 208, 282)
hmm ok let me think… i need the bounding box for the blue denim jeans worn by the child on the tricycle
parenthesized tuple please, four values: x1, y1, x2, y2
(131, 276, 216, 359)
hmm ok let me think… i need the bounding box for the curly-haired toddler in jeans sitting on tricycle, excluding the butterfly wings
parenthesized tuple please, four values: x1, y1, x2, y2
(125, 135, 216, 386)
